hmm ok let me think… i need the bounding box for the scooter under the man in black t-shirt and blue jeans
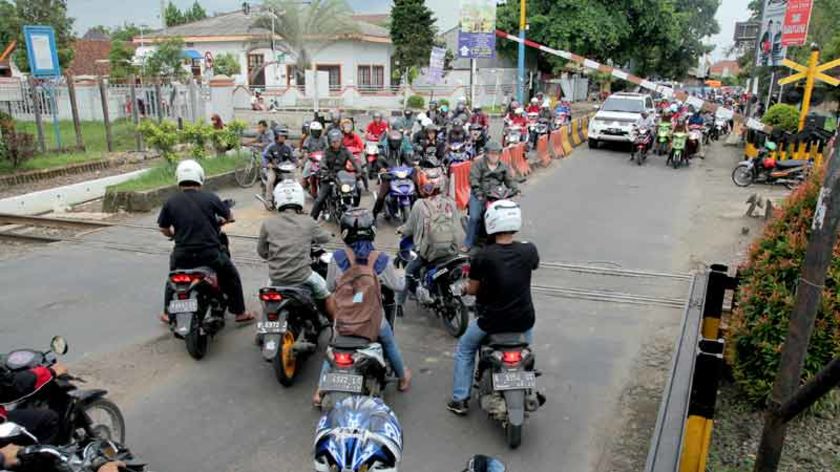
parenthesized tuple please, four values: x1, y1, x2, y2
(475, 333, 545, 449)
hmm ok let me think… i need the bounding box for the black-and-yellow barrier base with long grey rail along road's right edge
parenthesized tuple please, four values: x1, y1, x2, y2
(644, 264, 738, 472)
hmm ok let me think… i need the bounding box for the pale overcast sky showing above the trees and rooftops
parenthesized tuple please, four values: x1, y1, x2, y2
(67, 0, 749, 58)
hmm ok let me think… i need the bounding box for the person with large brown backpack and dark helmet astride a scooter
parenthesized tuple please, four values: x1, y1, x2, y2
(312, 208, 411, 406)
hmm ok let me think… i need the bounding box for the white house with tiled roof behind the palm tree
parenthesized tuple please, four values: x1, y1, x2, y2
(133, 8, 392, 94)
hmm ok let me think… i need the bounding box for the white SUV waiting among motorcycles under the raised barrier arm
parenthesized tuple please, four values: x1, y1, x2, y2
(589, 92, 655, 148)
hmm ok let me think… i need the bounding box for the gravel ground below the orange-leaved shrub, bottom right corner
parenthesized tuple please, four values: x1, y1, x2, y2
(706, 383, 840, 472)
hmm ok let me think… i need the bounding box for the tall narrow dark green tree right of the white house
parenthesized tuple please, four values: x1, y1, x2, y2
(390, 0, 437, 79)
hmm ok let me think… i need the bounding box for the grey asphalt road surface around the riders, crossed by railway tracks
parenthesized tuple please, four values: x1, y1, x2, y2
(0, 139, 736, 472)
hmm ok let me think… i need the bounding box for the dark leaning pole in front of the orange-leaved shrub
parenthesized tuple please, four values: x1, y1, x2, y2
(753, 145, 840, 472)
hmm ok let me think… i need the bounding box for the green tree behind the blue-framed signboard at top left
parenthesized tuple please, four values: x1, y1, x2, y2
(8, 0, 75, 72)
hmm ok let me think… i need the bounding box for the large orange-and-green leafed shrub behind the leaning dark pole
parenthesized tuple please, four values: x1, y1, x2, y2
(728, 171, 840, 406)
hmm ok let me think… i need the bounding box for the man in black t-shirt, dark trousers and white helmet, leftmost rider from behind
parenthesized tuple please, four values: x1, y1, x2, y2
(158, 160, 254, 324)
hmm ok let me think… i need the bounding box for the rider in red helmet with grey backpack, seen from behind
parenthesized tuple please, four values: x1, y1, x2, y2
(397, 169, 464, 309)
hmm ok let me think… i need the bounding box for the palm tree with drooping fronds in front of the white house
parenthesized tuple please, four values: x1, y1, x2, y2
(254, 0, 359, 84)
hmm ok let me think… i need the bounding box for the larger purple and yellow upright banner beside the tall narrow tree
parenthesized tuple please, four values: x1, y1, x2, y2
(458, 0, 496, 59)
